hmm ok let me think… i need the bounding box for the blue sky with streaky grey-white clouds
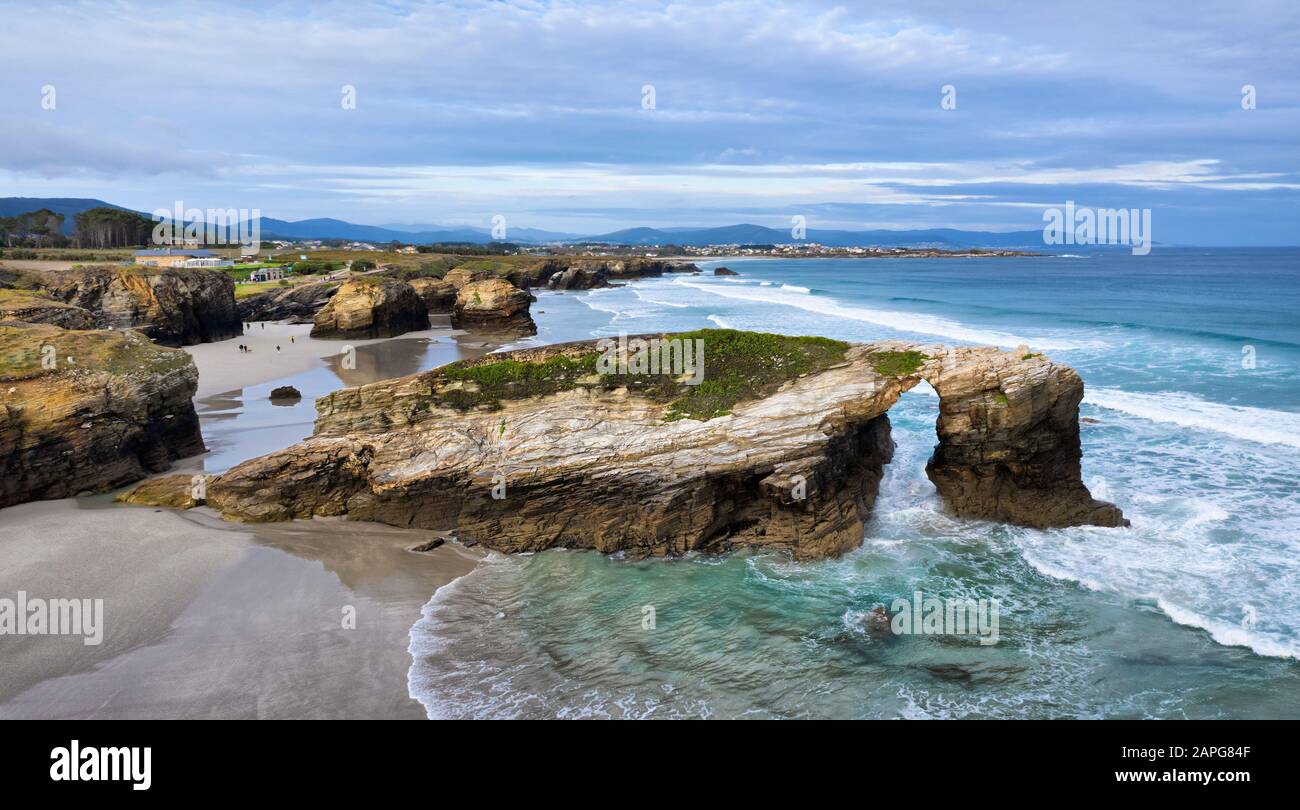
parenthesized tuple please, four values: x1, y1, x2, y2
(0, 0, 1300, 244)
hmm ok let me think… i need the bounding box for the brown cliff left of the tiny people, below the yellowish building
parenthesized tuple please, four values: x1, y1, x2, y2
(49, 267, 243, 346)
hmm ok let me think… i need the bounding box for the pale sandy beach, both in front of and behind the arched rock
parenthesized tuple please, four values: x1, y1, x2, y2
(0, 322, 494, 719)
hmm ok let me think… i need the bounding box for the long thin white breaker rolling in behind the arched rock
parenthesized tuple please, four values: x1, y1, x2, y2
(673, 278, 1083, 350)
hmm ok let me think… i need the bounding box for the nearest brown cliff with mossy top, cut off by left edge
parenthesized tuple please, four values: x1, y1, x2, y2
(0, 321, 204, 507)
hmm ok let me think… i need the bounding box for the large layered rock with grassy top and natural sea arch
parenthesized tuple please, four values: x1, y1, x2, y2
(119, 330, 1123, 558)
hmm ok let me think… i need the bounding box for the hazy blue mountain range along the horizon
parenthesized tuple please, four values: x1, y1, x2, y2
(0, 196, 1043, 248)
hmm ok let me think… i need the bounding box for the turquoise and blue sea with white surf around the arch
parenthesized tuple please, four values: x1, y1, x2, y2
(410, 248, 1300, 718)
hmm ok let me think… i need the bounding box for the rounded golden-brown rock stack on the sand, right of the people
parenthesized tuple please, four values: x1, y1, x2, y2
(312, 276, 429, 338)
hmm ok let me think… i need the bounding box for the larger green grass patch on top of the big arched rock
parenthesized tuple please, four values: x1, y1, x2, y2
(433, 329, 849, 421)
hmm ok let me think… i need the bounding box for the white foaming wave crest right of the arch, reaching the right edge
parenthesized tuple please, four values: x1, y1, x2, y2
(1084, 387, 1300, 449)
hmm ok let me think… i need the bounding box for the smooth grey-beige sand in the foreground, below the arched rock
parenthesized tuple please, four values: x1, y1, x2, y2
(0, 497, 478, 719)
